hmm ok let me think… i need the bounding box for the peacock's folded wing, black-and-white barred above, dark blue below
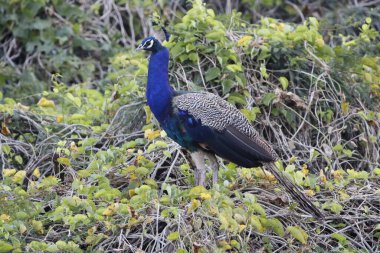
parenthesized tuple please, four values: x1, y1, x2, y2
(173, 93, 277, 167)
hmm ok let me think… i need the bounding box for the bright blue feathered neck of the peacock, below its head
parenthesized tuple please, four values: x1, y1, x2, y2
(146, 47, 173, 122)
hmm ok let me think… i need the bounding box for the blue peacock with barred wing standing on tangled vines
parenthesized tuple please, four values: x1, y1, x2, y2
(137, 29, 323, 217)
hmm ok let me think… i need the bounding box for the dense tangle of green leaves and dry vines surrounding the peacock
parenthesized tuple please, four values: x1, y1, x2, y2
(0, 0, 380, 252)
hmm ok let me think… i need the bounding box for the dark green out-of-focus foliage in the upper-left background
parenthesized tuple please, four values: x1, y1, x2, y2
(0, 0, 152, 103)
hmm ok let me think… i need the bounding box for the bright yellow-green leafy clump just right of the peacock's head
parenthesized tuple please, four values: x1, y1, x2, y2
(166, 0, 246, 96)
